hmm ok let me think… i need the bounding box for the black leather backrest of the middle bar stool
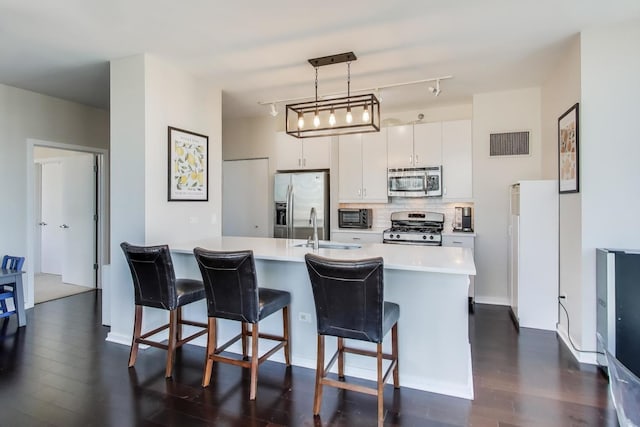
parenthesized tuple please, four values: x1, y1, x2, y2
(193, 248, 260, 323)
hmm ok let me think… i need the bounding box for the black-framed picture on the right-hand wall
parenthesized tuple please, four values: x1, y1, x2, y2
(558, 102, 580, 194)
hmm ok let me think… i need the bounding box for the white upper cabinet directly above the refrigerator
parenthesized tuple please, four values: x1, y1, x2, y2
(276, 132, 331, 170)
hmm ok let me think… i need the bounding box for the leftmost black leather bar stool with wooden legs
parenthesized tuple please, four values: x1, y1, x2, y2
(120, 242, 207, 378)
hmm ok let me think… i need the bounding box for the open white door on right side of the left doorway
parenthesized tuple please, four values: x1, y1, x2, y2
(58, 153, 96, 288)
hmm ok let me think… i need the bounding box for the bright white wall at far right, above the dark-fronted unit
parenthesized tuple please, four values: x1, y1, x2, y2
(571, 20, 640, 362)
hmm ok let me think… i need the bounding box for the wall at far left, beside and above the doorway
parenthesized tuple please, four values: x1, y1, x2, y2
(0, 84, 109, 303)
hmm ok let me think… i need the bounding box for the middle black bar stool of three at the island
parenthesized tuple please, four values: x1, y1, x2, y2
(193, 248, 291, 400)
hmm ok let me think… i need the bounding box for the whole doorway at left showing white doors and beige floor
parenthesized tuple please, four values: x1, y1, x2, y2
(33, 150, 98, 304)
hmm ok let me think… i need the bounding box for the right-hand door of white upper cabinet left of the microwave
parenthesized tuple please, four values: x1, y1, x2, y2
(362, 129, 389, 203)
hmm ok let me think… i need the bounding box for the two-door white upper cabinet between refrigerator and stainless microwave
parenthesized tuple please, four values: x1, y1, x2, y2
(338, 129, 388, 203)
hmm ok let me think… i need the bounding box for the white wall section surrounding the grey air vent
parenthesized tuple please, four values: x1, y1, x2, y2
(473, 88, 542, 305)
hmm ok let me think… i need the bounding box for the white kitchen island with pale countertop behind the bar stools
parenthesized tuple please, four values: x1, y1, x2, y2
(112, 237, 476, 399)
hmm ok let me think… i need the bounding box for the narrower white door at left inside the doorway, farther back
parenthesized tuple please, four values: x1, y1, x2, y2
(39, 162, 64, 274)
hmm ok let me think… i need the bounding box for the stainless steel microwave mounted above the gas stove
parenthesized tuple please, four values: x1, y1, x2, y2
(388, 166, 442, 197)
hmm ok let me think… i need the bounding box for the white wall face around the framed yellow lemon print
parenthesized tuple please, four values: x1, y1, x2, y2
(145, 55, 222, 242)
